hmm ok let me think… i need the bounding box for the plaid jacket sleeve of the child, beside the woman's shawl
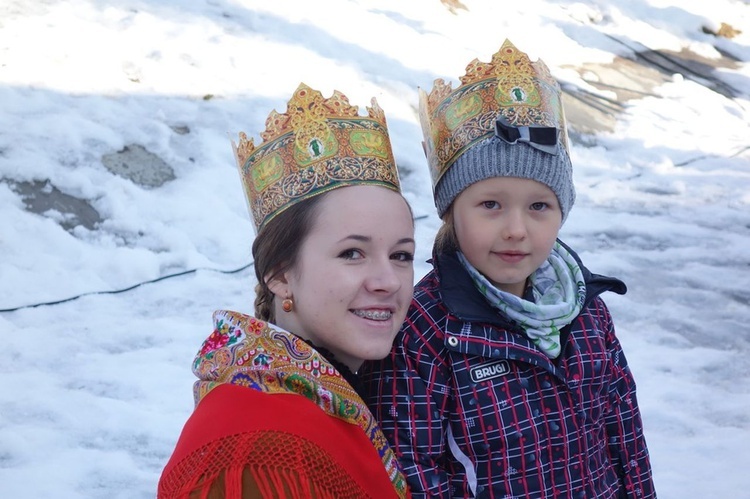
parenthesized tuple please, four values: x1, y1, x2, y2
(362, 301, 455, 498)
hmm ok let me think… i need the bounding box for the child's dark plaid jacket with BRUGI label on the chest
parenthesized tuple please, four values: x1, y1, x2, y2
(361, 246, 656, 499)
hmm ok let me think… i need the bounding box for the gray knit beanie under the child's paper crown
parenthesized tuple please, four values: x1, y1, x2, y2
(435, 135, 576, 222)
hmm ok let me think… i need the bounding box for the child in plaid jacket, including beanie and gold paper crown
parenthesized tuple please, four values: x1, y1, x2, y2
(363, 40, 655, 499)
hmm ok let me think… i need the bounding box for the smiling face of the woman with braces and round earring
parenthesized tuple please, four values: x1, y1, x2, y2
(269, 186, 414, 371)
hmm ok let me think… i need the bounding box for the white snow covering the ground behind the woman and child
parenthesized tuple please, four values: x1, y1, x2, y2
(0, 0, 750, 499)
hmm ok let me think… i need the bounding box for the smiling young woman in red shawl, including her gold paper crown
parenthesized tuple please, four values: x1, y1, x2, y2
(158, 84, 414, 499)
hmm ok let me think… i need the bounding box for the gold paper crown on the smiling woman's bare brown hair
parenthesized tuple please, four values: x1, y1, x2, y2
(232, 83, 400, 233)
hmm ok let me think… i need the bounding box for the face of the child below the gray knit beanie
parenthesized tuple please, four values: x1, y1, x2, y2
(453, 177, 562, 296)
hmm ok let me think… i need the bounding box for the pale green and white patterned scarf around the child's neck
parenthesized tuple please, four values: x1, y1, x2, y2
(458, 242, 586, 359)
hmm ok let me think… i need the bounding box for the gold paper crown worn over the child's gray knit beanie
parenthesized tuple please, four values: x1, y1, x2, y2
(419, 39, 568, 189)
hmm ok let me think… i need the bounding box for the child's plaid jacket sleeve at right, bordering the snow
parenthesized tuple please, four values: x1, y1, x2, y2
(595, 299, 656, 499)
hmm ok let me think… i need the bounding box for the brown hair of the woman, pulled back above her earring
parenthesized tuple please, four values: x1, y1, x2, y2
(253, 193, 327, 322)
